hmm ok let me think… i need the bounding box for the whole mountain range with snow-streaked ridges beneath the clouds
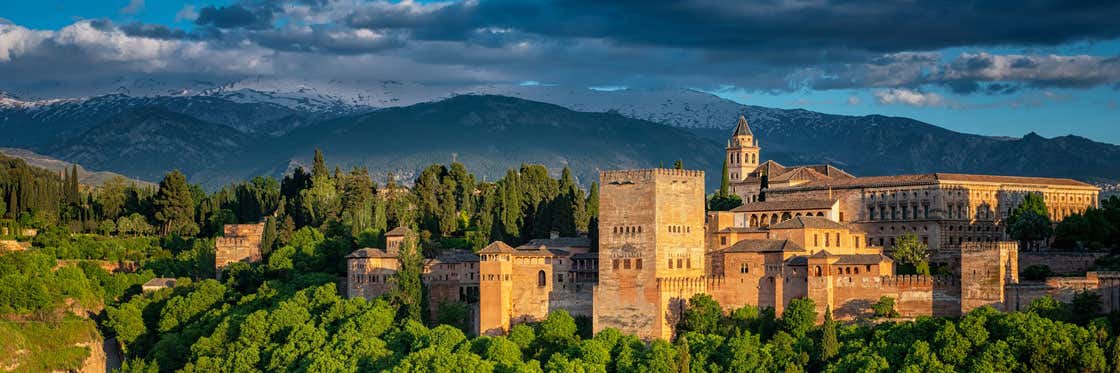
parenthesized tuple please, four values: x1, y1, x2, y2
(0, 81, 1120, 189)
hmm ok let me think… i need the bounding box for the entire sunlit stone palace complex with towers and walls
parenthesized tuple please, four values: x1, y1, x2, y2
(346, 118, 1120, 338)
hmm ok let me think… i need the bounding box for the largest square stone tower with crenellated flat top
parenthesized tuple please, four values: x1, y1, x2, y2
(594, 169, 704, 339)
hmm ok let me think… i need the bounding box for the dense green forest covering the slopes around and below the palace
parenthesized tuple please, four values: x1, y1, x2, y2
(0, 152, 1120, 372)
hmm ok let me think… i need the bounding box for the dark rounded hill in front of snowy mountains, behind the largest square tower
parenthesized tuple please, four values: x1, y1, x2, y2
(260, 95, 721, 184)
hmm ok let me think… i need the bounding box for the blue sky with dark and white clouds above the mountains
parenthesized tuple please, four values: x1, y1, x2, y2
(0, 0, 1120, 143)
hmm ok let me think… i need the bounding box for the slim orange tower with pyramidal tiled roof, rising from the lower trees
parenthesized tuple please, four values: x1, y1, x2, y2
(478, 241, 514, 335)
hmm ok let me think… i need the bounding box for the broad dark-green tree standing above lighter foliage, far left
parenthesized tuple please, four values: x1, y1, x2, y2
(152, 170, 198, 236)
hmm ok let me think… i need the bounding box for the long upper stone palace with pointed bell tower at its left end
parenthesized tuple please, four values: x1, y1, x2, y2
(727, 116, 1100, 251)
